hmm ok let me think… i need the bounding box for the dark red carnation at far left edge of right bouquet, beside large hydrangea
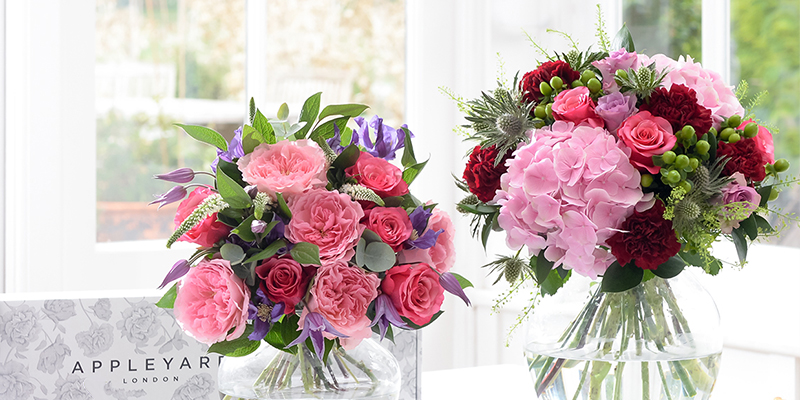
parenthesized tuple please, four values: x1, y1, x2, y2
(464, 146, 511, 203)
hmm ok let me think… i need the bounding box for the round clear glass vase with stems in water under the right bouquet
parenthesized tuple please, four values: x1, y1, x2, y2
(524, 271, 722, 400)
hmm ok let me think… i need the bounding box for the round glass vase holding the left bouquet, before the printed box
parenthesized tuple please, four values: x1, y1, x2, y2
(217, 339, 400, 400)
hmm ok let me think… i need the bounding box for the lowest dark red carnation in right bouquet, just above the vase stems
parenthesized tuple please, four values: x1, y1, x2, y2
(606, 201, 681, 269)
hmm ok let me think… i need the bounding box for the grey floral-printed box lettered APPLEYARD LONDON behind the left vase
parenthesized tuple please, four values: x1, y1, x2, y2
(0, 293, 421, 400)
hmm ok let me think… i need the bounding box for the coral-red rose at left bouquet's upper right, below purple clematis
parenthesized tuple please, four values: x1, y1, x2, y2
(345, 152, 408, 197)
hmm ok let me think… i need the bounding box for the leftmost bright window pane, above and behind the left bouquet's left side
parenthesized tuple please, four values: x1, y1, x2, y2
(95, 0, 245, 242)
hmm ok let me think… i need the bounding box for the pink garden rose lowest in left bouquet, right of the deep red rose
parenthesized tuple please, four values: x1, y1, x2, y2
(308, 260, 381, 349)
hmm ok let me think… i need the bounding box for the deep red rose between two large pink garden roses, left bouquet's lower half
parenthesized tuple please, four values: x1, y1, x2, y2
(256, 257, 316, 314)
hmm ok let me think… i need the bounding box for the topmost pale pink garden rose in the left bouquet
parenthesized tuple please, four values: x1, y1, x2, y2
(237, 139, 328, 199)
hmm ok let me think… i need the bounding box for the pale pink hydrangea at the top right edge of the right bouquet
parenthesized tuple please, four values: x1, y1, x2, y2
(639, 54, 744, 129)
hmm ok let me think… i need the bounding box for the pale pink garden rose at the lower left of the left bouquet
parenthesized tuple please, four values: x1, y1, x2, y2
(174, 259, 250, 345)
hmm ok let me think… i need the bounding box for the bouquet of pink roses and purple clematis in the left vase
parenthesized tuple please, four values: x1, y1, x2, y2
(153, 93, 470, 396)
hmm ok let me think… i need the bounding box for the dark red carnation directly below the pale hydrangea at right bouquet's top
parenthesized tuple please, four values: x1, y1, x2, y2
(639, 85, 712, 138)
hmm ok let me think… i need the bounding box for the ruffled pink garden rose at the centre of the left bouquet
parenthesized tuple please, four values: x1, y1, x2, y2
(284, 189, 364, 264)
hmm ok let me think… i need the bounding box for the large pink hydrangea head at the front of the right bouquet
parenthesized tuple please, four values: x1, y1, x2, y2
(496, 121, 643, 279)
